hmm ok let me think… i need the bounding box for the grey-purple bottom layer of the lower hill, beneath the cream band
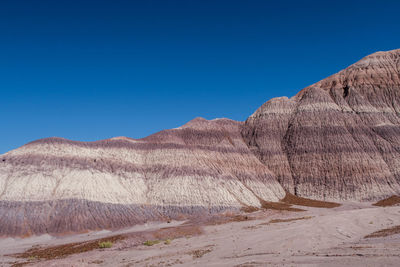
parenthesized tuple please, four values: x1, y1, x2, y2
(0, 199, 234, 237)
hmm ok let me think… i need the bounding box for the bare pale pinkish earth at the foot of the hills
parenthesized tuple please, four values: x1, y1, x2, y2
(0, 203, 400, 266)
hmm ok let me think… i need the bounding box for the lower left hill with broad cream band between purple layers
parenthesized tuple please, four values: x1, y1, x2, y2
(0, 118, 284, 235)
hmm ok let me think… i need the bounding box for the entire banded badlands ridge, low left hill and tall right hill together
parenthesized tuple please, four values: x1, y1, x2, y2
(0, 50, 400, 236)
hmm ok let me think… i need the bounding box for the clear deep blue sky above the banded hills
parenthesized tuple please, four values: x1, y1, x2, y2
(0, 0, 400, 153)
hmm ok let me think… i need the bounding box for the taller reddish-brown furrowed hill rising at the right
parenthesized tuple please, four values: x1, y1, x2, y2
(242, 50, 400, 201)
